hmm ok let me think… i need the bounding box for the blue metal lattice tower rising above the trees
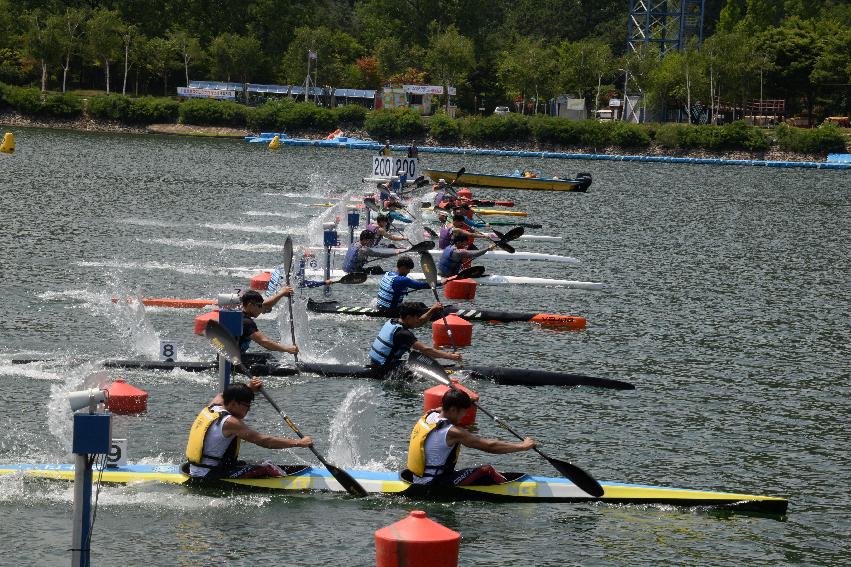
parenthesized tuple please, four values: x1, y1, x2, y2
(627, 0, 704, 57)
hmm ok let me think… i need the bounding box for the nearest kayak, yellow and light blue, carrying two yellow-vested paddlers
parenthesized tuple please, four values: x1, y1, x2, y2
(0, 464, 789, 516)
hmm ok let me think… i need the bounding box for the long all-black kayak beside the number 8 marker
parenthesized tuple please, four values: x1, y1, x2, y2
(12, 353, 635, 390)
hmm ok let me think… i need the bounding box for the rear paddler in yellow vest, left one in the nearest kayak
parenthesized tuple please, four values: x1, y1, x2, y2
(186, 378, 313, 480)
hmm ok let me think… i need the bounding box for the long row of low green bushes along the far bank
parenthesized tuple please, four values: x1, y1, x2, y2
(0, 83, 848, 159)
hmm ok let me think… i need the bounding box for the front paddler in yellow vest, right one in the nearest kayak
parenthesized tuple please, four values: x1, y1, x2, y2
(408, 389, 535, 486)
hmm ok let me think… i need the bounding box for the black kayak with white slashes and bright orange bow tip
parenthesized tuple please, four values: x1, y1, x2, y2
(307, 298, 587, 330)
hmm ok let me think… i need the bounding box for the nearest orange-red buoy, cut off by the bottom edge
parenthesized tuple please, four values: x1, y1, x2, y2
(375, 510, 461, 567)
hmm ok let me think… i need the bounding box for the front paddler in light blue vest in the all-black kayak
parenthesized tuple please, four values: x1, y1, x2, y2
(369, 301, 463, 374)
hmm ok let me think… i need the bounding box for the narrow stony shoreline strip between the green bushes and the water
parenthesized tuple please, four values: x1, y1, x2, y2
(0, 112, 840, 163)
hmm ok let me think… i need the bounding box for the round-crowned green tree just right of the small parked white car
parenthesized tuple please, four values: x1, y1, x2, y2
(496, 37, 556, 114)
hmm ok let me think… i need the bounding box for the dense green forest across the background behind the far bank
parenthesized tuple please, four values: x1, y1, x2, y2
(0, 0, 851, 124)
